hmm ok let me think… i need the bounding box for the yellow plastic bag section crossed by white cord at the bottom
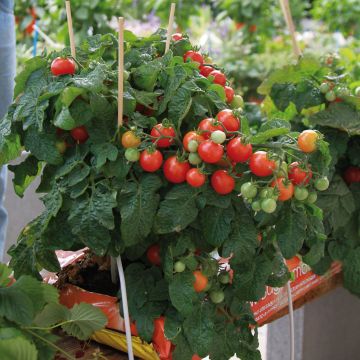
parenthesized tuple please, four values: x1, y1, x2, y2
(91, 329, 159, 360)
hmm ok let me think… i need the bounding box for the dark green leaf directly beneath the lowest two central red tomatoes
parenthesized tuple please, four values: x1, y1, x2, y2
(154, 184, 198, 234)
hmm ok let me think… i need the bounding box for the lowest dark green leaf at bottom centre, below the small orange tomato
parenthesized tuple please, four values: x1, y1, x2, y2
(183, 302, 215, 357)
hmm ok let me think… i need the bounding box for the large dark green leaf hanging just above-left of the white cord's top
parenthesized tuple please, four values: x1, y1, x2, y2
(68, 183, 116, 255)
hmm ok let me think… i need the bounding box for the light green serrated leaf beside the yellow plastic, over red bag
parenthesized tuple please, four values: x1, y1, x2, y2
(61, 303, 107, 340)
